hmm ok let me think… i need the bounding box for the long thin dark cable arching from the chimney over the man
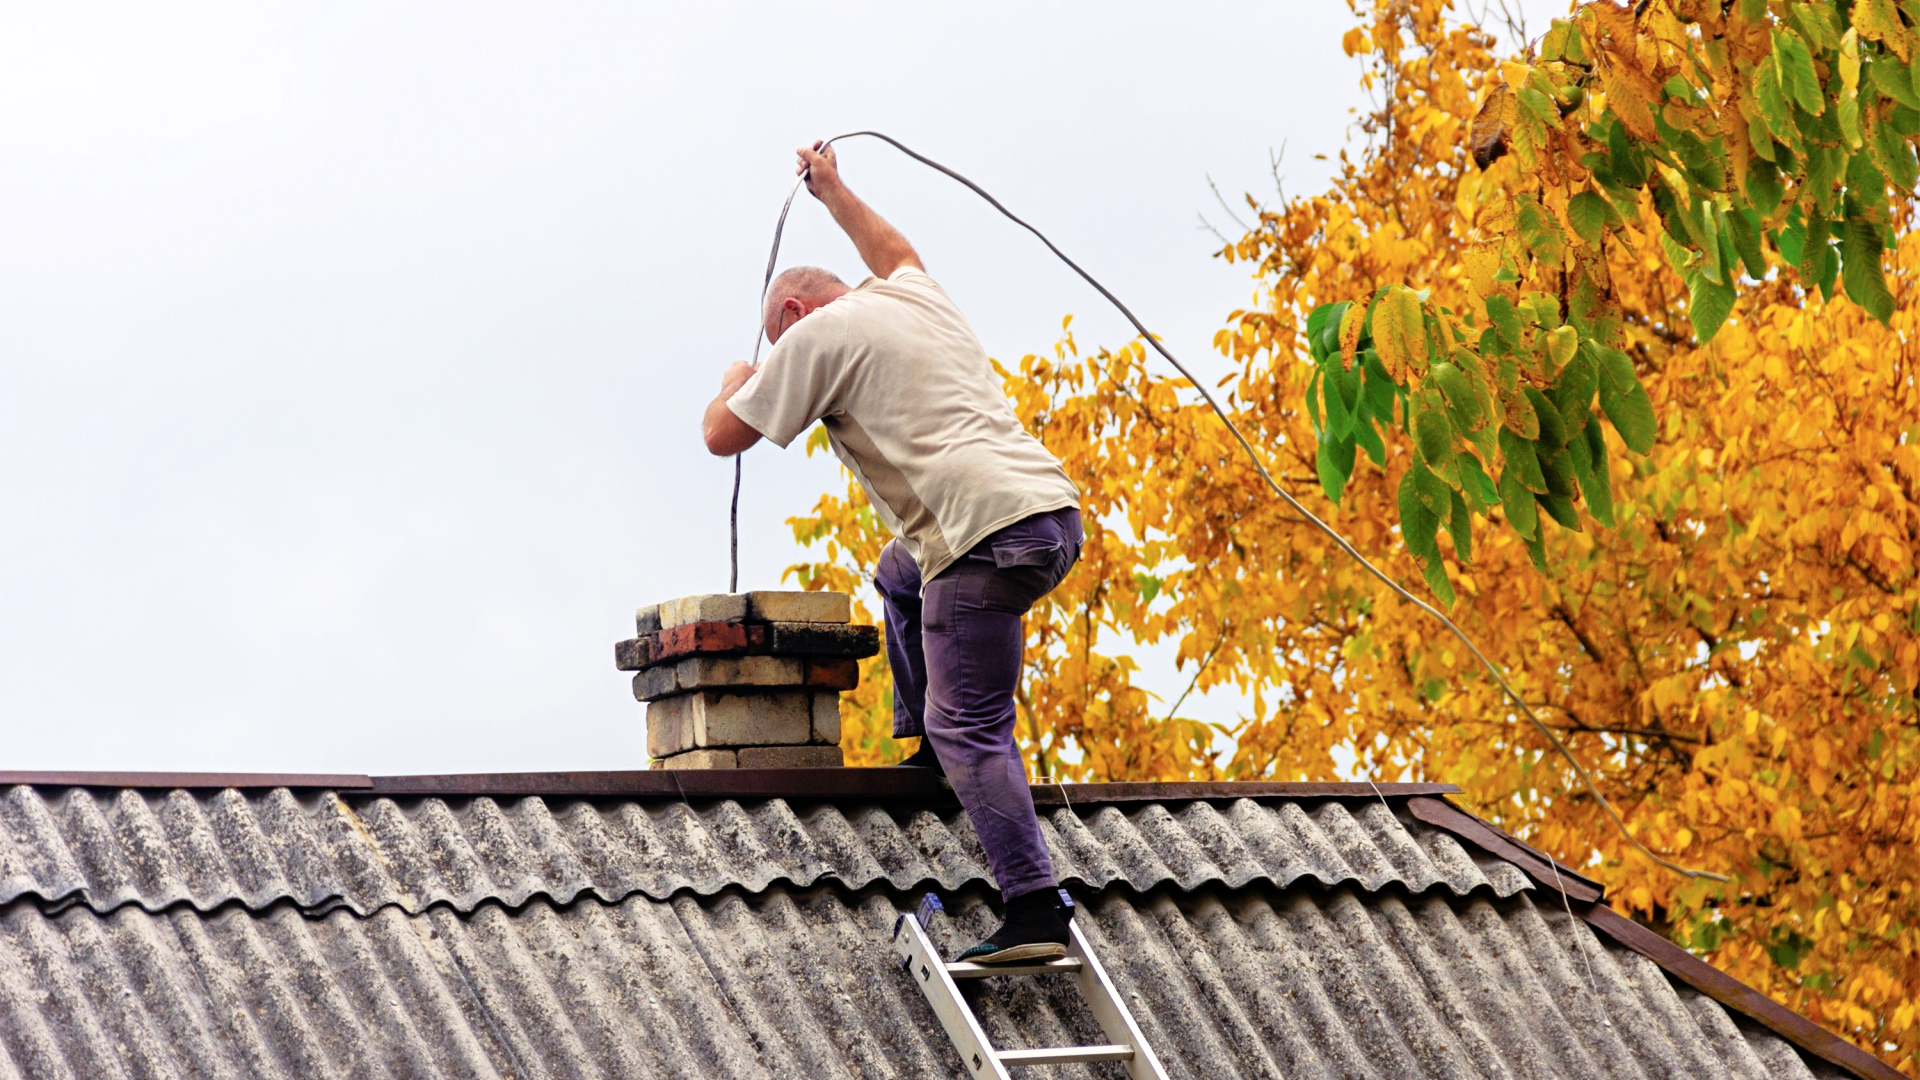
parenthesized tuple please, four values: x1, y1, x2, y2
(733, 131, 1732, 882)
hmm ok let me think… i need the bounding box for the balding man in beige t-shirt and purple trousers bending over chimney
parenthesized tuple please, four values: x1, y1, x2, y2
(705, 142, 1081, 963)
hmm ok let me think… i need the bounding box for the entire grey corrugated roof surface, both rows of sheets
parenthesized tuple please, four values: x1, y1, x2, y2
(0, 771, 1893, 1080)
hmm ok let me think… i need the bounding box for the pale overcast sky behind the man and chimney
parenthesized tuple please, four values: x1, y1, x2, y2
(0, 0, 1557, 773)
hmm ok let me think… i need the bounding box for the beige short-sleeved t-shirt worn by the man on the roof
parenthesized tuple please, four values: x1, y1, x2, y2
(728, 267, 1079, 580)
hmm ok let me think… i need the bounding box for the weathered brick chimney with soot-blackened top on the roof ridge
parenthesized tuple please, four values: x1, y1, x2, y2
(614, 592, 879, 769)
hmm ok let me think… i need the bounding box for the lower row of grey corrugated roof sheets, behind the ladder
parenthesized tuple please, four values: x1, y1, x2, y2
(0, 884, 1839, 1080)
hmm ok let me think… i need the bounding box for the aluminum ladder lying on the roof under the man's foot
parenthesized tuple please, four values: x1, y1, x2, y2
(893, 890, 1167, 1080)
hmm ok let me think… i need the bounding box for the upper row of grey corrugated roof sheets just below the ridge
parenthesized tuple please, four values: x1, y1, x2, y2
(0, 786, 1528, 915)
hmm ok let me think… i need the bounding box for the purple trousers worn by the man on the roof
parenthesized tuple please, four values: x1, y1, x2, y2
(874, 507, 1083, 899)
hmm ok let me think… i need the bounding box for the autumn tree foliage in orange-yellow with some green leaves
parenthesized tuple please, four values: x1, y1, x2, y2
(795, 0, 1920, 1068)
